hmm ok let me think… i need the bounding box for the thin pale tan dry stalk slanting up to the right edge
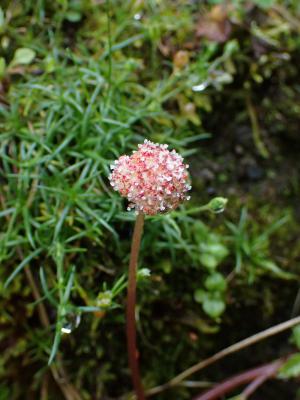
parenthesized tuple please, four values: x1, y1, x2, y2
(146, 317, 300, 396)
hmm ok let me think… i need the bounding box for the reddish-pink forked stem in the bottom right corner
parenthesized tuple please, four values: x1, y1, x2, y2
(193, 359, 284, 400)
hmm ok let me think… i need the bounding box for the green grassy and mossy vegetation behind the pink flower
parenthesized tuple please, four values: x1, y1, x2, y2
(0, 0, 300, 400)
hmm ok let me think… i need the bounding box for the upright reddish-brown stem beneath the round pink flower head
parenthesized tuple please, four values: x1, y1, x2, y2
(126, 213, 145, 400)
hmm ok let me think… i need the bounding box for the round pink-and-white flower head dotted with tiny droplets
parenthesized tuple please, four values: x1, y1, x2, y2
(109, 140, 191, 215)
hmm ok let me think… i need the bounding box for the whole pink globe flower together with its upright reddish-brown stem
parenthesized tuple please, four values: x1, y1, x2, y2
(109, 139, 191, 400)
